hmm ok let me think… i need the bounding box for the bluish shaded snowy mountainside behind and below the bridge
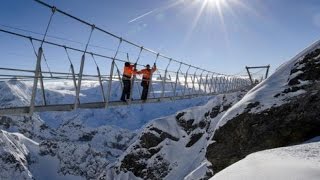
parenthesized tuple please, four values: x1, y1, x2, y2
(0, 79, 215, 179)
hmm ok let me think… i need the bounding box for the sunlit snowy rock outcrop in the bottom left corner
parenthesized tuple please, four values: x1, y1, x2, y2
(0, 130, 83, 180)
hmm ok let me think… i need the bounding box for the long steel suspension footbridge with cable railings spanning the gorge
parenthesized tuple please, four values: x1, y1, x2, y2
(0, 0, 252, 115)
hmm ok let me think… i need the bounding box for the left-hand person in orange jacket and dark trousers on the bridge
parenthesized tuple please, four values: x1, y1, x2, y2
(121, 62, 137, 102)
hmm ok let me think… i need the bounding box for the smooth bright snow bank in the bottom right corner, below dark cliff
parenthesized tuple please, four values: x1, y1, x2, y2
(210, 142, 320, 180)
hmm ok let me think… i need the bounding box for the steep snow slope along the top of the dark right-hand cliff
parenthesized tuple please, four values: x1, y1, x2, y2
(218, 41, 320, 127)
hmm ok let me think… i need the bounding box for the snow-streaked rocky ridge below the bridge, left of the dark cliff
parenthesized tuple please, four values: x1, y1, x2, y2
(101, 92, 244, 179)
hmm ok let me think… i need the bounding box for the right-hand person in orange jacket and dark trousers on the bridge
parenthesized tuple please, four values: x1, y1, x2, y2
(136, 63, 157, 101)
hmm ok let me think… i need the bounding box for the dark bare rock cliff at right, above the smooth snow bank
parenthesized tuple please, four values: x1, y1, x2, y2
(206, 46, 320, 173)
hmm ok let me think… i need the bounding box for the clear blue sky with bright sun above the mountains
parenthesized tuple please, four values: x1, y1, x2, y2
(0, 0, 320, 75)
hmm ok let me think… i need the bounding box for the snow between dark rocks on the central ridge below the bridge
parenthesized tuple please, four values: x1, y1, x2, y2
(112, 92, 244, 180)
